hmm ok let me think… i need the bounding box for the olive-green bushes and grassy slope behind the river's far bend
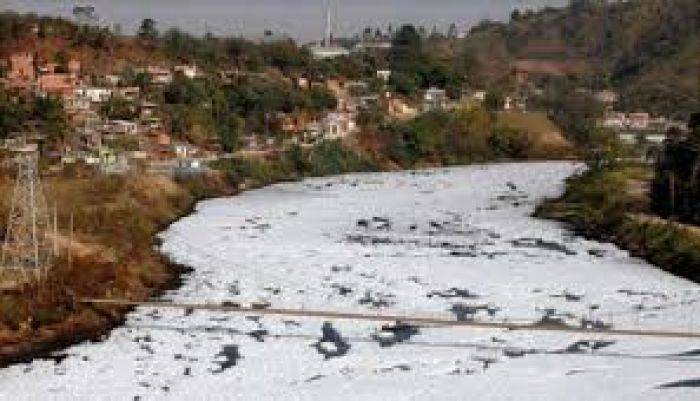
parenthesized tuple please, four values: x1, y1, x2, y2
(360, 106, 571, 168)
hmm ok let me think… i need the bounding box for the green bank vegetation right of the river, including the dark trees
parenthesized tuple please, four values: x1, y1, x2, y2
(536, 114, 700, 282)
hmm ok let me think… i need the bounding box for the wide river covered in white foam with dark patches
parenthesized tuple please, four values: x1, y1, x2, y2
(0, 162, 700, 401)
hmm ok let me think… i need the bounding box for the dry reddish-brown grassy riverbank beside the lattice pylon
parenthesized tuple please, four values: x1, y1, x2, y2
(0, 173, 235, 367)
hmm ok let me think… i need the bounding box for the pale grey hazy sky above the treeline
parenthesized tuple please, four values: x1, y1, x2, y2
(0, 0, 568, 41)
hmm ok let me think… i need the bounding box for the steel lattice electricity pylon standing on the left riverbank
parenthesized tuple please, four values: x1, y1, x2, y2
(0, 148, 56, 280)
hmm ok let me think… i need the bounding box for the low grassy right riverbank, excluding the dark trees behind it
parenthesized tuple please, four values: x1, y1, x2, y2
(535, 166, 700, 283)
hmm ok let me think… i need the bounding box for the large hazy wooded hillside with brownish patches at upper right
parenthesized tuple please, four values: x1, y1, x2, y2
(461, 0, 700, 119)
